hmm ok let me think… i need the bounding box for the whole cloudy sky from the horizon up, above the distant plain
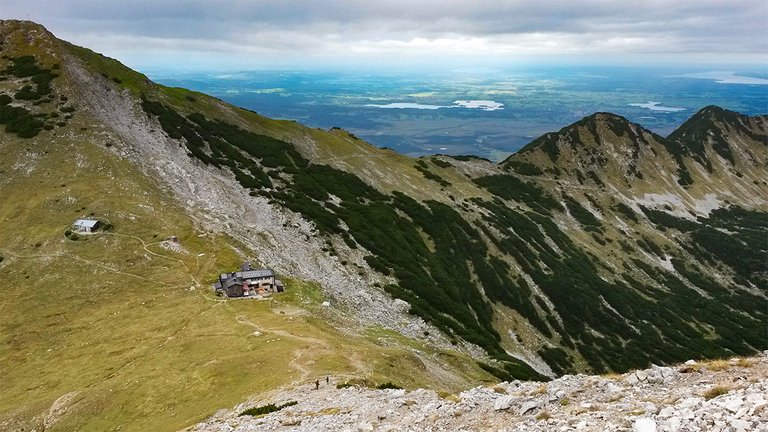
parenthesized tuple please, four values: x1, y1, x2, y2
(0, 0, 768, 70)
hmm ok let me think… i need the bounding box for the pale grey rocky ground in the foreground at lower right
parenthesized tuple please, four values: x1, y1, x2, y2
(189, 352, 768, 432)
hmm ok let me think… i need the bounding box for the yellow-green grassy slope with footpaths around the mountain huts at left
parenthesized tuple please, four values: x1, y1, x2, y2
(0, 105, 487, 430)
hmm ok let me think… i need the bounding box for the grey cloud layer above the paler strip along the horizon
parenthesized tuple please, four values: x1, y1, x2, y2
(0, 0, 768, 64)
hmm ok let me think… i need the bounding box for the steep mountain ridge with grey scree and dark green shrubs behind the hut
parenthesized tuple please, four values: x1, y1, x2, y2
(0, 21, 768, 432)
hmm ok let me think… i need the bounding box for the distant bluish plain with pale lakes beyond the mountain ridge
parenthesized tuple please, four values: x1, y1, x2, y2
(148, 66, 768, 160)
